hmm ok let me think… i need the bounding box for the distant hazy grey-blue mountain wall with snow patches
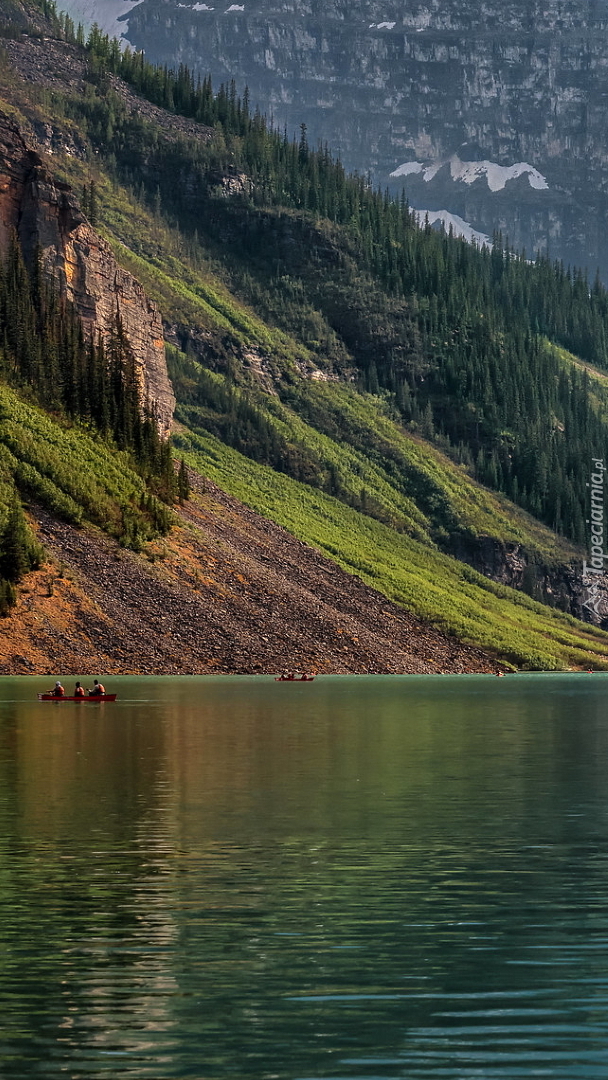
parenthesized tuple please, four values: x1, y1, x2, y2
(64, 0, 608, 281)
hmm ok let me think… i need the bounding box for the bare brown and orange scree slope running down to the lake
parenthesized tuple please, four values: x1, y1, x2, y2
(0, 483, 507, 675)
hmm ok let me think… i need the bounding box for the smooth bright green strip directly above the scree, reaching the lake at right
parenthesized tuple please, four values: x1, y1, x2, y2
(176, 433, 608, 670)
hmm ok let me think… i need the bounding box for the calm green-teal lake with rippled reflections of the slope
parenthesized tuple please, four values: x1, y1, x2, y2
(0, 674, 608, 1080)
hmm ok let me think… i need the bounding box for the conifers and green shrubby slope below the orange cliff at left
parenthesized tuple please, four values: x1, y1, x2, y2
(0, 227, 176, 613)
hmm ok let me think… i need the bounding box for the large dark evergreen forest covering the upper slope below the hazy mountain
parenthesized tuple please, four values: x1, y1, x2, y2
(46, 28, 608, 542)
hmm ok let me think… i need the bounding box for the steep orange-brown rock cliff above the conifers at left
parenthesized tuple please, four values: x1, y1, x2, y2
(0, 116, 175, 436)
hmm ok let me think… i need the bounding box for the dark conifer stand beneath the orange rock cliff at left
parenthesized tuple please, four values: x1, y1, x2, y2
(0, 232, 188, 615)
